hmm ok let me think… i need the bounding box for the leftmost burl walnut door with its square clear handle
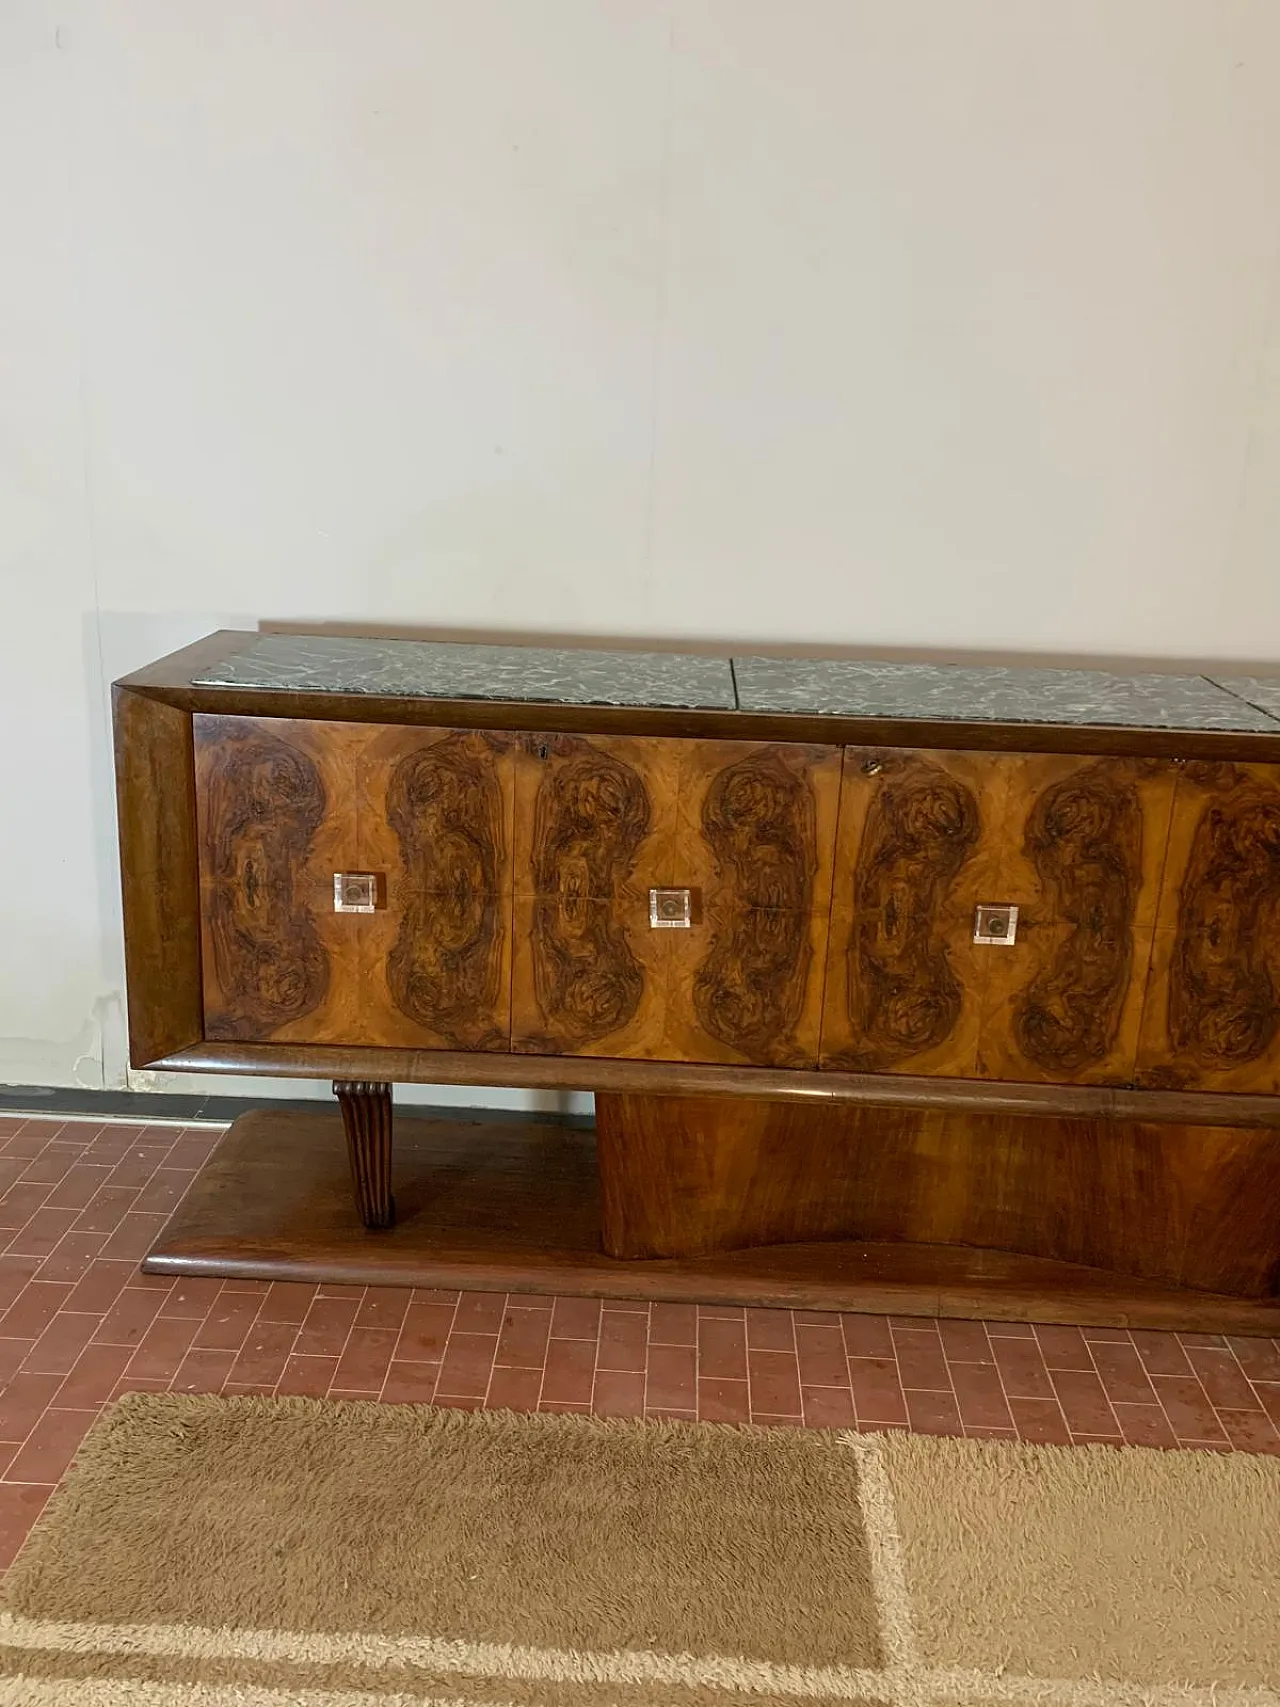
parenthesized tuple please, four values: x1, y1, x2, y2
(195, 715, 512, 1050)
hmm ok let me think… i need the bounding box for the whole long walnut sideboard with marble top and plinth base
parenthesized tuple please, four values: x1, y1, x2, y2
(114, 633, 1280, 1331)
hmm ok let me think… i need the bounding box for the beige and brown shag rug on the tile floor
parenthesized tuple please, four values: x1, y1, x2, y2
(0, 1395, 1280, 1707)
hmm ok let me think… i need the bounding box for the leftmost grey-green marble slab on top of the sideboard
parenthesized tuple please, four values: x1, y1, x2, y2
(193, 633, 734, 712)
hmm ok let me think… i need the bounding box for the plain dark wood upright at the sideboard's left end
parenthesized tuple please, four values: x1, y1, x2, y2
(113, 688, 203, 1067)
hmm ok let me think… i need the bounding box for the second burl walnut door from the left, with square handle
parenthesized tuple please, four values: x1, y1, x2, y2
(512, 736, 840, 1065)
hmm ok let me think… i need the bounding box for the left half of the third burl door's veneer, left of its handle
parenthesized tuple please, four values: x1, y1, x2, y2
(823, 748, 1007, 1074)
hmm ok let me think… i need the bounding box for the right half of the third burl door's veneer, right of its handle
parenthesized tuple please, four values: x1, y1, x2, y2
(978, 754, 1176, 1084)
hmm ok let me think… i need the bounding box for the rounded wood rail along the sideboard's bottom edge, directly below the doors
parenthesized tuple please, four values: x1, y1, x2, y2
(155, 1043, 1280, 1127)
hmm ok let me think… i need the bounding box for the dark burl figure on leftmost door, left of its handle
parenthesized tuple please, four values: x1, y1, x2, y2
(196, 717, 329, 1040)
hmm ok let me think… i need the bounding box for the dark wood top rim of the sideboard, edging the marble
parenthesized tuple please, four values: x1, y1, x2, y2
(119, 628, 1280, 763)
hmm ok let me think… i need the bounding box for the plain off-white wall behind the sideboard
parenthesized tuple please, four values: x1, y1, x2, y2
(0, 0, 1280, 1099)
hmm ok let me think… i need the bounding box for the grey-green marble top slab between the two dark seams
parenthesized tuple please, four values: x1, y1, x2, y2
(734, 657, 1280, 734)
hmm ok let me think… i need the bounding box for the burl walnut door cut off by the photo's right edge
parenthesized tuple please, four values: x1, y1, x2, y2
(1138, 763, 1280, 1094)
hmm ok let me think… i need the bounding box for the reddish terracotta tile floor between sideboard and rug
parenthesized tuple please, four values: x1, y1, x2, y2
(0, 1118, 1280, 1567)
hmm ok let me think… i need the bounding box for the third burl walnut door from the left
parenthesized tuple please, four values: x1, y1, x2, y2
(823, 749, 1172, 1084)
